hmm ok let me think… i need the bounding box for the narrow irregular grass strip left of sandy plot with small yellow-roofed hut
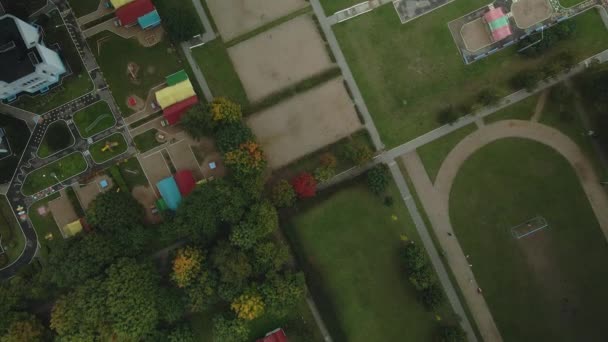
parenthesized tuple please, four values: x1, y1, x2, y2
(28, 192, 63, 260)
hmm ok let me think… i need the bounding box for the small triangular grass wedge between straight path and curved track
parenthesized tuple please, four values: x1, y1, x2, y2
(417, 123, 477, 182)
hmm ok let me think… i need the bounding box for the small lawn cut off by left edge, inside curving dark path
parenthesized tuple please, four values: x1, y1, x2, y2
(0, 195, 25, 268)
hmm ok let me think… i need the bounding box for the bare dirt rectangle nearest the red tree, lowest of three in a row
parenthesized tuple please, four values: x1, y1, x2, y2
(248, 78, 361, 168)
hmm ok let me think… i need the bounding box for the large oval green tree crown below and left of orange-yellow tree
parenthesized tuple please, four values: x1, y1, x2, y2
(104, 259, 159, 339)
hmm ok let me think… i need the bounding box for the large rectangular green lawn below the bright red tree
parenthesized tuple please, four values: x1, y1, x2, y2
(287, 183, 452, 342)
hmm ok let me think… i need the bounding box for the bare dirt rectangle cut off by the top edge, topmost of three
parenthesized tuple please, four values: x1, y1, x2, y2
(207, 0, 308, 41)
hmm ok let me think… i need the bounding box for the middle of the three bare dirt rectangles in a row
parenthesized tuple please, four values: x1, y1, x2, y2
(228, 15, 332, 102)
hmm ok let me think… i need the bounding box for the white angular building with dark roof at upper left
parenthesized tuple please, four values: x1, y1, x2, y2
(0, 14, 66, 101)
